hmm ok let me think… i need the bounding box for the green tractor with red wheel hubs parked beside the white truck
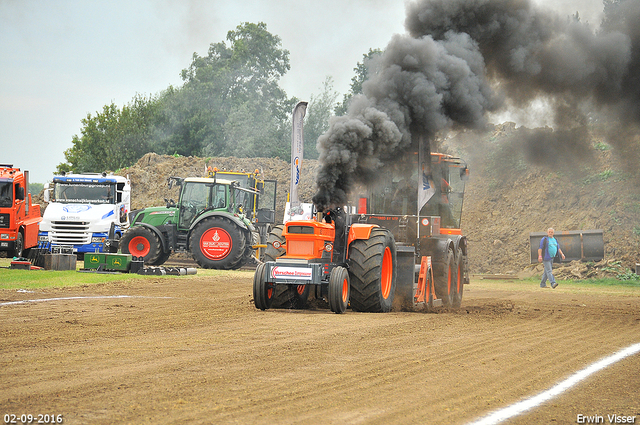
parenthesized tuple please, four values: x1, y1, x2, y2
(119, 173, 275, 269)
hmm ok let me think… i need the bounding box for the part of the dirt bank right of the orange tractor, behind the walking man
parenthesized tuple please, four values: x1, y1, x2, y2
(447, 123, 640, 278)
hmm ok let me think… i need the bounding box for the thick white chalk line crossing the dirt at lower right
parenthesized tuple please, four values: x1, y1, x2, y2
(469, 343, 640, 425)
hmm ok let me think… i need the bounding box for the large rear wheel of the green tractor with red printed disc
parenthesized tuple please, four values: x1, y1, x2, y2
(189, 217, 246, 270)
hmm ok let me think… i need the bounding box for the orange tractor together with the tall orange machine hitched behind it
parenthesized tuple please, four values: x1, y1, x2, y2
(253, 153, 469, 313)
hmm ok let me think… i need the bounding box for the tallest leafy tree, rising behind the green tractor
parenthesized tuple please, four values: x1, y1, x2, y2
(166, 22, 292, 156)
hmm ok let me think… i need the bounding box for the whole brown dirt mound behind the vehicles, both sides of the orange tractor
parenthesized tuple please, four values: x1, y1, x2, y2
(112, 123, 640, 278)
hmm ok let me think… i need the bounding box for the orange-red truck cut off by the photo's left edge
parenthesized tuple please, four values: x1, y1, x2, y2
(0, 164, 42, 257)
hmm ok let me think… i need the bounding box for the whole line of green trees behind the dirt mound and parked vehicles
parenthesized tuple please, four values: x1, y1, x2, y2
(57, 22, 380, 173)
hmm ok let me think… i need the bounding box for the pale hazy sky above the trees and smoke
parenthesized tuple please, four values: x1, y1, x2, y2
(0, 0, 602, 183)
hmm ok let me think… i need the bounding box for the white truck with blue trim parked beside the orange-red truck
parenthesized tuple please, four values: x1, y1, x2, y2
(39, 173, 131, 254)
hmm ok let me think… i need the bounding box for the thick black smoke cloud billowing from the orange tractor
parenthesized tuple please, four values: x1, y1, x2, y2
(313, 0, 640, 209)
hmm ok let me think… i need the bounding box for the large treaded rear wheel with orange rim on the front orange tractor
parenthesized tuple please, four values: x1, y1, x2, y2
(349, 228, 397, 313)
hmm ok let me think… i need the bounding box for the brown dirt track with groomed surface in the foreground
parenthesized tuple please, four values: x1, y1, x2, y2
(0, 271, 640, 424)
